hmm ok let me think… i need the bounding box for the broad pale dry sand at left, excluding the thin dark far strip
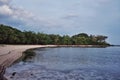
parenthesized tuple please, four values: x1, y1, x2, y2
(0, 45, 55, 67)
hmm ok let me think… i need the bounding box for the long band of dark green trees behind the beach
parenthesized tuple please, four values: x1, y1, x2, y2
(0, 24, 109, 45)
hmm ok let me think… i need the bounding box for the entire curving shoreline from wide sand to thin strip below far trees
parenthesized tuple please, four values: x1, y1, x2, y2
(0, 45, 108, 67)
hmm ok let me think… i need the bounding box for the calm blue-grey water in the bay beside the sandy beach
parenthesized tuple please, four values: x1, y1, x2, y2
(5, 47, 120, 80)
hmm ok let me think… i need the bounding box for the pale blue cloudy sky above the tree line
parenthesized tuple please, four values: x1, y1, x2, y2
(0, 0, 120, 44)
